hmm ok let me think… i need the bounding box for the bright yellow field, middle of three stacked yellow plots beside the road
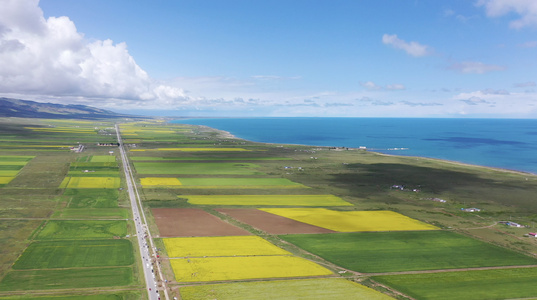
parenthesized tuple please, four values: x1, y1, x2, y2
(170, 256, 332, 282)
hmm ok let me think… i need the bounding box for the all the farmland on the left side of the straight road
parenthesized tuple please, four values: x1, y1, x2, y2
(0, 119, 137, 300)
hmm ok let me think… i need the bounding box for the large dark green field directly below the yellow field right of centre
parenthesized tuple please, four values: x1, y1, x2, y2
(280, 231, 537, 273)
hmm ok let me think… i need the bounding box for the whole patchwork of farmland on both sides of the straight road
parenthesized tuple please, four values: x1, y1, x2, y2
(5, 120, 537, 300)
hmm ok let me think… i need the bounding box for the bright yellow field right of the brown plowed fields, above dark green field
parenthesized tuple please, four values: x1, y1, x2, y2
(261, 208, 438, 232)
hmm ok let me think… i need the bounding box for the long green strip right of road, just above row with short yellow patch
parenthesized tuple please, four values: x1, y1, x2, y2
(134, 162, 264, 175)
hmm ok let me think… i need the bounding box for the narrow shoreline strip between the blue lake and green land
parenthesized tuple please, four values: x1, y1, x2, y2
(191, 124, 537, 177)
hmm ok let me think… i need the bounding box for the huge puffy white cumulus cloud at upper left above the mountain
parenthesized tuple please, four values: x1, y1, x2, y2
(0, 0, 187, 104)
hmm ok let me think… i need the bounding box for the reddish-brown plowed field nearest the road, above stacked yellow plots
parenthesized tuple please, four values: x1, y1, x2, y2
(152, 208, 250, 237)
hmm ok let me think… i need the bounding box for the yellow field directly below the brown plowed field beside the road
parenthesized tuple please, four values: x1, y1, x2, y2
(163, 236, 291, 257)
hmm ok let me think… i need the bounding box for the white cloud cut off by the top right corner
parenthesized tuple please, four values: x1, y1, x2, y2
(476, 0, 537, 29)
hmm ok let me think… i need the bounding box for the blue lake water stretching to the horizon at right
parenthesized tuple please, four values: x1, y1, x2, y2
(173, 118, 537, 174)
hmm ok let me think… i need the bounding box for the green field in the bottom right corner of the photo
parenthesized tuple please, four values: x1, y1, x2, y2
(373, 268, 537, 300)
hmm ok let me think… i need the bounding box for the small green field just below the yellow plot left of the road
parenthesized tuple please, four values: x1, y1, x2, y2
(62, 189, 119, 208)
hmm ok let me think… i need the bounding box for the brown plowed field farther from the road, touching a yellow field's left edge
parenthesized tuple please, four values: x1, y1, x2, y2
(217, 208, 335, 234)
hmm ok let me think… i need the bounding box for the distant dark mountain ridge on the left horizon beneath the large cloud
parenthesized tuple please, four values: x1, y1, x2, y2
(0, 97, 136, 119)
